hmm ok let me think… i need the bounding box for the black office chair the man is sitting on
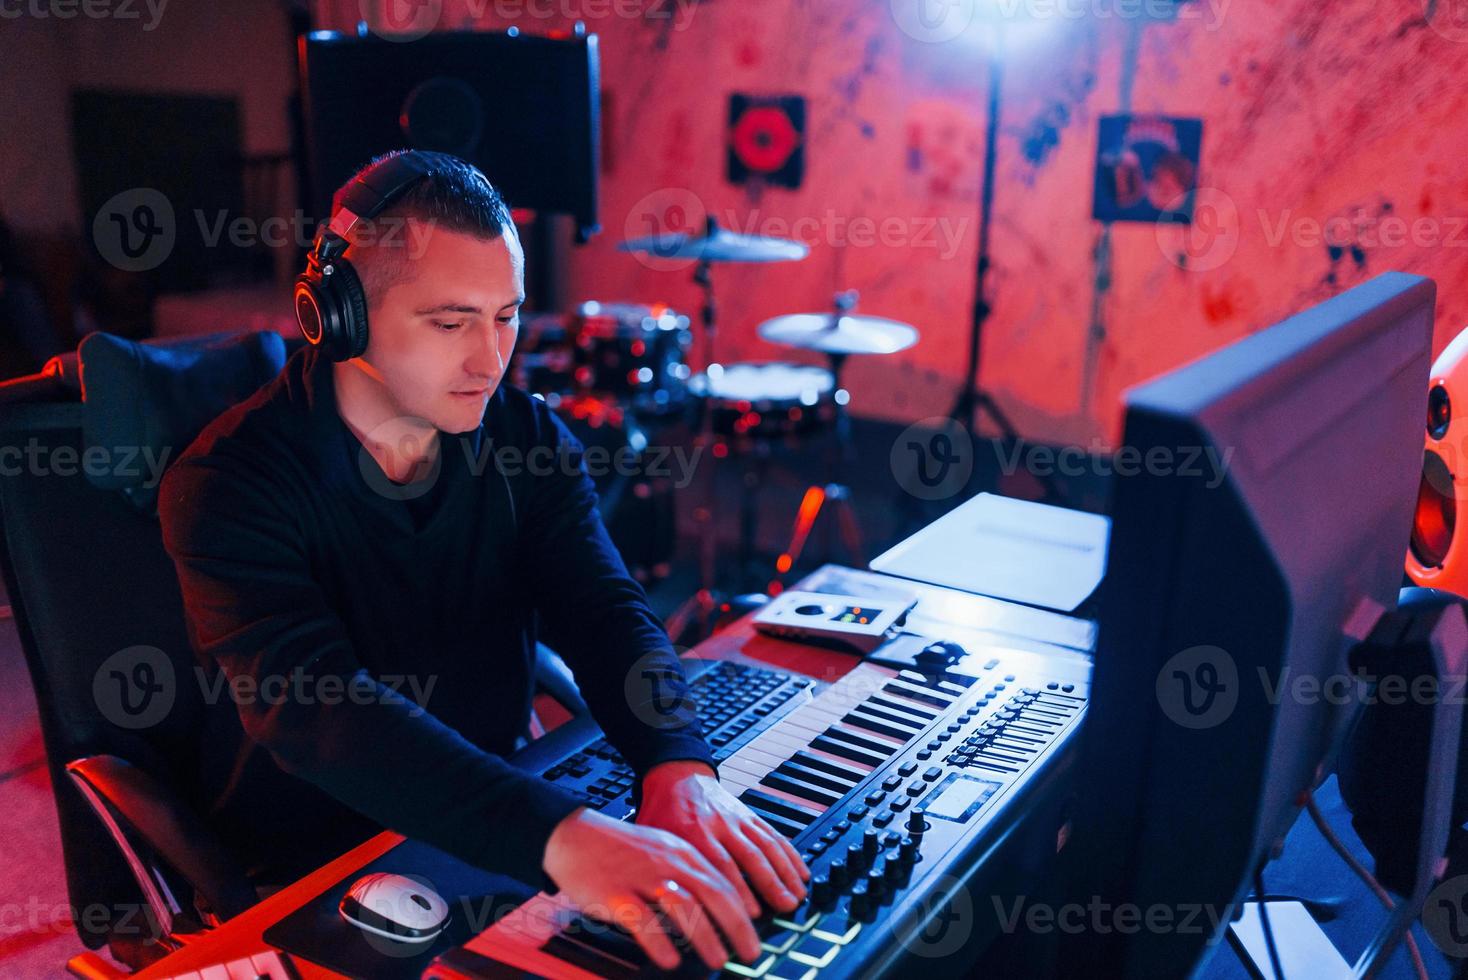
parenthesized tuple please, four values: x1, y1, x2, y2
(0, 333, 586, 979)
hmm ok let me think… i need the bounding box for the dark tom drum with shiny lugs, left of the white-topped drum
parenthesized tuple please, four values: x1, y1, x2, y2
(568, 301, 693, 415)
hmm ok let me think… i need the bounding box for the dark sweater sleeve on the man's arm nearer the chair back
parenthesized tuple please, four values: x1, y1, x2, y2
(159, 453, 581, 891)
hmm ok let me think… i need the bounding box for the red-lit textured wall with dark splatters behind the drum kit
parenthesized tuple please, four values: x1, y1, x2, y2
(319, 0, 1468, 445)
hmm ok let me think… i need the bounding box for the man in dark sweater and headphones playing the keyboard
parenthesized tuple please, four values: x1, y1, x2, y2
(159, 153, 809, 968)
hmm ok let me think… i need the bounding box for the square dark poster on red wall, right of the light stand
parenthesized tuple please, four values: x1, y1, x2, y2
(1091, 116, 1202, 224)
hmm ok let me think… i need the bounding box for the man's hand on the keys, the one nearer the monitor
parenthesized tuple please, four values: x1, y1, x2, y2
(637, 760, 810, 918)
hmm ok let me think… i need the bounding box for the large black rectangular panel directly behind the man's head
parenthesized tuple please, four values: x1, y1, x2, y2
(299, 31, 600, 235)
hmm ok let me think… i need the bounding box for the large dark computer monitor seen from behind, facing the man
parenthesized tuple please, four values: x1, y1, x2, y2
(1069, 273, 1436, 979)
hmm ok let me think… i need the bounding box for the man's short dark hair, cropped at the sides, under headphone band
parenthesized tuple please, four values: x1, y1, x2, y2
(332, 150, 520, 305)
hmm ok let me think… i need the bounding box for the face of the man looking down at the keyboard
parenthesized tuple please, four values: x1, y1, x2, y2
(353, 219, 524, 433)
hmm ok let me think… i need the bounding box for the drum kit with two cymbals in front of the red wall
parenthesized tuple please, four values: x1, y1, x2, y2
(511, 219, 918, 638)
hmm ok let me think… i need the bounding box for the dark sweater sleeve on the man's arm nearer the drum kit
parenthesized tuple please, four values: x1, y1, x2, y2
(520, 402, 718, 798)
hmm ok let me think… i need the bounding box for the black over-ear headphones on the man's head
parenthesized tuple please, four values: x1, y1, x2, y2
(295, 150, 462, 361)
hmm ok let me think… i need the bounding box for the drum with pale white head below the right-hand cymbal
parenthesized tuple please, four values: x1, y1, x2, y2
(688, 361, 835, 442)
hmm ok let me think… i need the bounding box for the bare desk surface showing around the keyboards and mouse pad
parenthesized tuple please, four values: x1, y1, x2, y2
(135, 565, 1092, 980)
